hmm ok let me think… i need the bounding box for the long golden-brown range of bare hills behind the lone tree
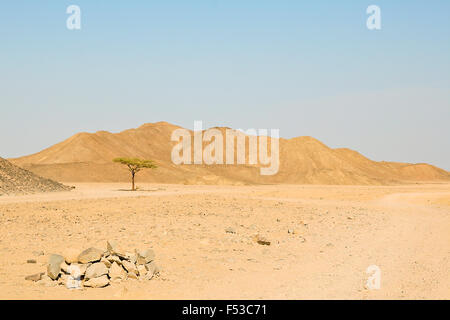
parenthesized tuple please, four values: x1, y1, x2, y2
(11, 122, 450, 185)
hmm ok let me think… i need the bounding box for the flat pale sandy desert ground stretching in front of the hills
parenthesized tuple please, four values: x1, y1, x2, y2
(0, 184, 450, 299)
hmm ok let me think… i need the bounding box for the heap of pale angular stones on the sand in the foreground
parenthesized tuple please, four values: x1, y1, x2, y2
(25, 241, 159, 289)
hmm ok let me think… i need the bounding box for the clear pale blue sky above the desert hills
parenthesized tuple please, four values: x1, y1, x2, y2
(0, 0, 450, 170)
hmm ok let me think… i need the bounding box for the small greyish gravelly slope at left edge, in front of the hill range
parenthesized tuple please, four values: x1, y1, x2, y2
(0, 158, 71, 196)
